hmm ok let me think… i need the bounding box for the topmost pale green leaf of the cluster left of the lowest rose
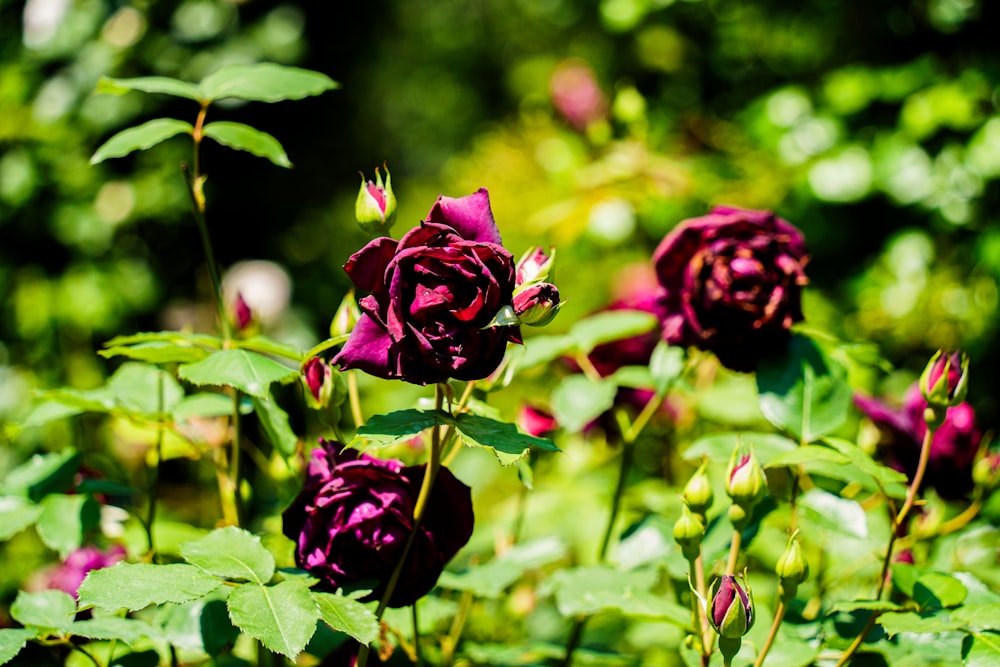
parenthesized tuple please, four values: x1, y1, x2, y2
(181, 526, 274, 584)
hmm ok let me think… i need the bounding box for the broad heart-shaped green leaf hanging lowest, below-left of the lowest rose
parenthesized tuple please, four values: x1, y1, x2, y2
(228, 579, 320, 660)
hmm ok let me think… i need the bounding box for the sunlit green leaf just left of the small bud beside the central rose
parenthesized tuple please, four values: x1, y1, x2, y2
(179, 350, 299, 398)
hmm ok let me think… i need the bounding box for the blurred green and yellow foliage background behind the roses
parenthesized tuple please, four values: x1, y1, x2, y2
(0, 0, 1000, 425)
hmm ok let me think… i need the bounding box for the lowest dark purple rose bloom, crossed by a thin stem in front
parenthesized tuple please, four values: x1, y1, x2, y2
(282, 440, 473, 607)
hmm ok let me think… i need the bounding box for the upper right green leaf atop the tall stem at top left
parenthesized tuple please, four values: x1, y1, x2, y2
(198, 63, 337, 102)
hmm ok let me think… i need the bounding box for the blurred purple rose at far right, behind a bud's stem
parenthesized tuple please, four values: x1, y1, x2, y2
(854, 384, 982, 499)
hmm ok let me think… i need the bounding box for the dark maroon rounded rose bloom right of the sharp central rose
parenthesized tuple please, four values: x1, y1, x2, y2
(653, 206, 809, 372)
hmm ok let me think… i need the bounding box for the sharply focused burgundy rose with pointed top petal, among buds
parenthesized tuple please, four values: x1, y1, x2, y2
(333, 188, 521, 384)
